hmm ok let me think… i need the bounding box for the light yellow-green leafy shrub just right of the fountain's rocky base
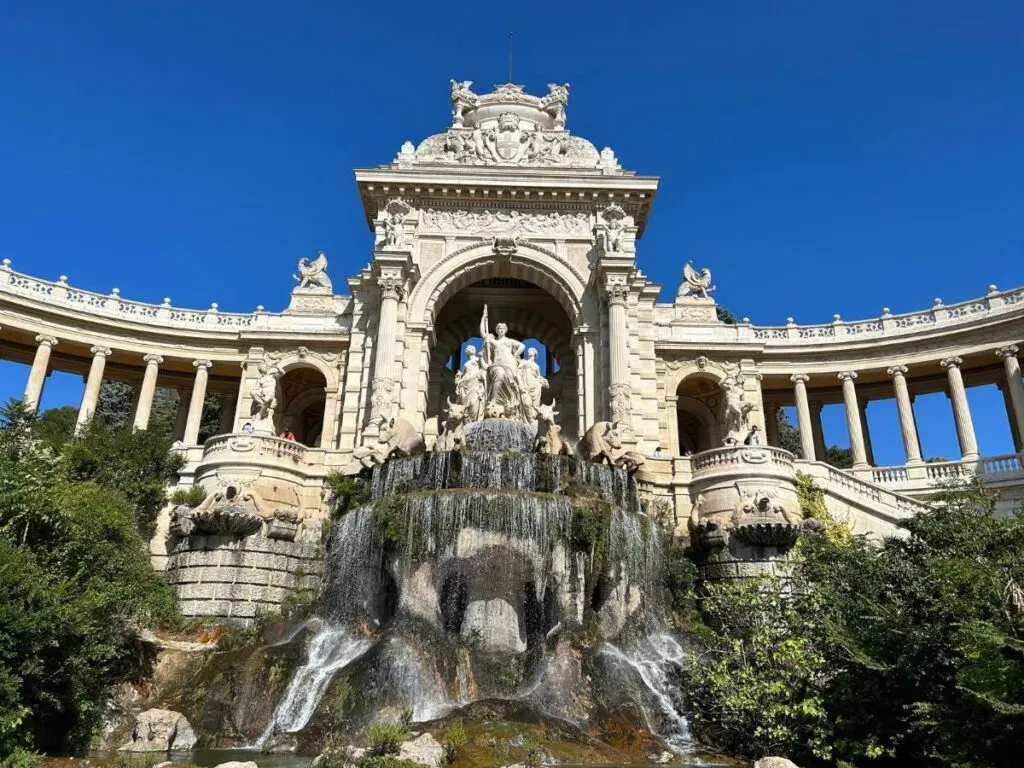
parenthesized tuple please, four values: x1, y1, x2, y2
(689, 579, 830, 759)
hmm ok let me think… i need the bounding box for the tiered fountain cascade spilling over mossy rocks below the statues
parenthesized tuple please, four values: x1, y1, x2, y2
(258, 420, 687, 745)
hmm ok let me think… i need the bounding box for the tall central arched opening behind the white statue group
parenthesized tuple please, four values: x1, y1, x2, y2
(427, 276, 579, 436)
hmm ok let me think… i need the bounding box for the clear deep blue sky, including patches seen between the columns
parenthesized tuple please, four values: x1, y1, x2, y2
(0, 0, 1024, 462)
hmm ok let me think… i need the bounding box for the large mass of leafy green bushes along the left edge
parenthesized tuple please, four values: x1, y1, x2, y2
(0, 401, 179, 755)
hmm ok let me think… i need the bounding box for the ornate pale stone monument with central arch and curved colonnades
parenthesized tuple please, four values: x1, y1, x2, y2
(0, 81, 1024, 617)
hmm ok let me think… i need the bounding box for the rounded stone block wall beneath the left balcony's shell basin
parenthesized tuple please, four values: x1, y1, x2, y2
(167, 528, 324, 625)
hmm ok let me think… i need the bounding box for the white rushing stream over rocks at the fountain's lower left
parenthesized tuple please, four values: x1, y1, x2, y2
(253, 623, 373, 749)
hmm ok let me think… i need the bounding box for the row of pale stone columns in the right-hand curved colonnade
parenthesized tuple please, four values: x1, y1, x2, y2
(765, 344, 1024, 469)
